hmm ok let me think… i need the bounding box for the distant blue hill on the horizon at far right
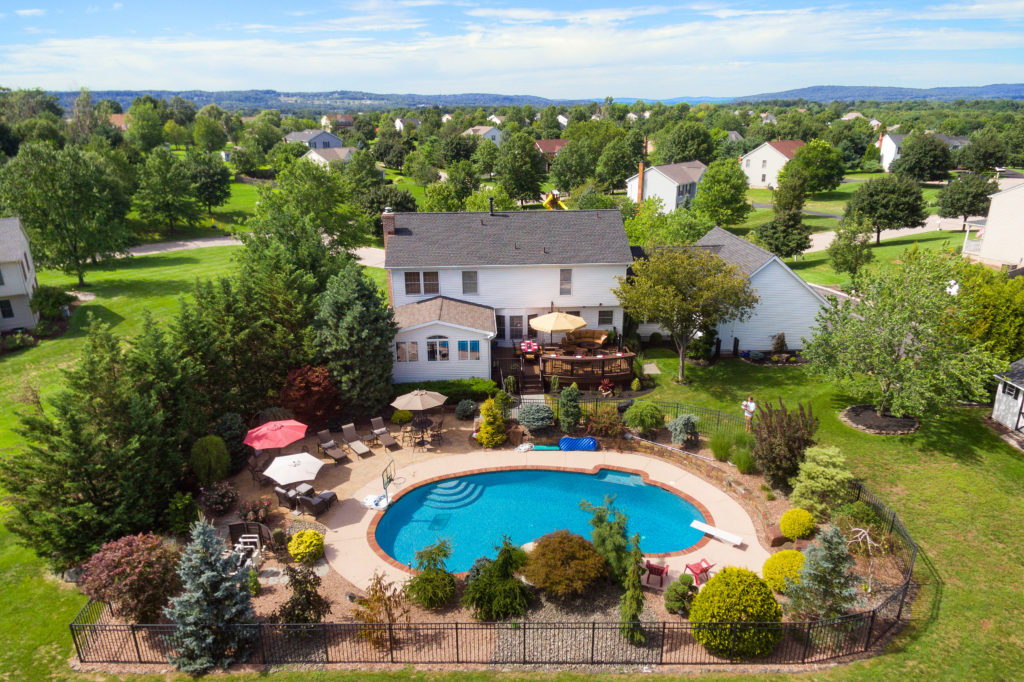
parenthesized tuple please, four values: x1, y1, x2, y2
(735, 83, 1024, 102)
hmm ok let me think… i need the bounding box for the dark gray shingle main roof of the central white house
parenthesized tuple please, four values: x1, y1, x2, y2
(384, 209, 633, 267)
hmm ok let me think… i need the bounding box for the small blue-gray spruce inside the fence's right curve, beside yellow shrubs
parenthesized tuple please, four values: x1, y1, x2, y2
(785, 528, 860, 620)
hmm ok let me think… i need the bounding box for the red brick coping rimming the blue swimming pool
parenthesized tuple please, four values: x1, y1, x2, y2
(367, 463, 715, 577)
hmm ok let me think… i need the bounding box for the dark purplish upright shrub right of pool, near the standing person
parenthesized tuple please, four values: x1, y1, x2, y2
(752, 398, 818, 487)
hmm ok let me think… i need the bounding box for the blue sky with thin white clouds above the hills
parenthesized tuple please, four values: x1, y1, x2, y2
(0, 0, 1024, 100)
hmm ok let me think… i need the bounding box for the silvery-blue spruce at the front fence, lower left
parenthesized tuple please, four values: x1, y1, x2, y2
(164, 521, 255, 675)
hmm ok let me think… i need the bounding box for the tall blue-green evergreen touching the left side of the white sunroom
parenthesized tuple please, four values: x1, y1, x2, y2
(314, 261, 397, 415)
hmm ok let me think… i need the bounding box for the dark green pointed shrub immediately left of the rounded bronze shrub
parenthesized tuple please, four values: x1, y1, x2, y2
(462, 538, 529, 621)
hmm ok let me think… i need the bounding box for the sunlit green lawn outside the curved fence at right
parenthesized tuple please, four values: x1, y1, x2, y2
(647, 349, 1024, 680)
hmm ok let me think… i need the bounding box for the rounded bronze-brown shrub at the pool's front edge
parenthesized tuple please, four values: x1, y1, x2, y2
(523, 530, 608, 597)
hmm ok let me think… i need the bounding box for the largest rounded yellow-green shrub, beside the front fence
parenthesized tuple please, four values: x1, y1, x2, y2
(690, 566, 782, 658)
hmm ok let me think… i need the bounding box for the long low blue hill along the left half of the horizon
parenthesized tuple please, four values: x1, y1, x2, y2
(53, 90, 590, 113)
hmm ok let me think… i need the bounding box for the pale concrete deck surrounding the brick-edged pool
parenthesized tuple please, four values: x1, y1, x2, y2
(317, 451, 770, 588)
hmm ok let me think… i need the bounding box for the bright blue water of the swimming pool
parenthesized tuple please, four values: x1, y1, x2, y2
(377, 469, 706, 572)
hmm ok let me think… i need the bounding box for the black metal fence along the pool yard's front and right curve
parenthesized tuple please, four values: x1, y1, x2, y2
(71, 477, 918, 666)
